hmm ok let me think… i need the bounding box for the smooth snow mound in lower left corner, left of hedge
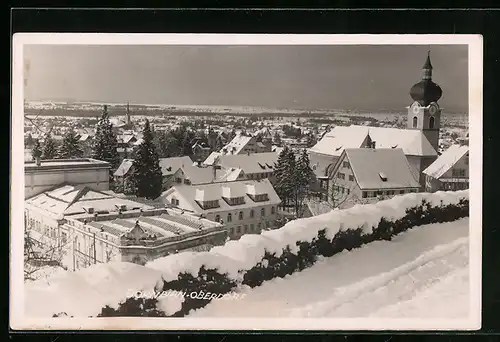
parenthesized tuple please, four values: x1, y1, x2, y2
(24, 262, 161, 317)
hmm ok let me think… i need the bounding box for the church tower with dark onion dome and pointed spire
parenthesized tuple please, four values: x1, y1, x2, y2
(407, 51, 443, 152)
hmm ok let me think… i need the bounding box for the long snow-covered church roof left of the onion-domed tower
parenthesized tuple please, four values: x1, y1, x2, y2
(311, 125, 437, 156)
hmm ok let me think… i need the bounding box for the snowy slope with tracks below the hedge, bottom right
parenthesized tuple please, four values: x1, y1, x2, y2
(189, 218, 469, 318)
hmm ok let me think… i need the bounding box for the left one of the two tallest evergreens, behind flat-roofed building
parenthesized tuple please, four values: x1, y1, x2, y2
(92, 106, 120, 175)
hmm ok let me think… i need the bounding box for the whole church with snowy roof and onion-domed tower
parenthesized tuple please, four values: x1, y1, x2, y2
(310, 53, 443, 191)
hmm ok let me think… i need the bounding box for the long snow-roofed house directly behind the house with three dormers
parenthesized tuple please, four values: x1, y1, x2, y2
(203, 152, 278, 184)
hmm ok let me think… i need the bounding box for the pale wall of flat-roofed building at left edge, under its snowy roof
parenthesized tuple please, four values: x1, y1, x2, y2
(24, 168, 109, 198)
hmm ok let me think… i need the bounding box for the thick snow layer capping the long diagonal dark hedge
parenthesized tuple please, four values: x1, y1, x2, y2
(146, 190, 469, 282)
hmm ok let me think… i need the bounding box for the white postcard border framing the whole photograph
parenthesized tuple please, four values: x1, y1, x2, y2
(10, 33, 483, 330)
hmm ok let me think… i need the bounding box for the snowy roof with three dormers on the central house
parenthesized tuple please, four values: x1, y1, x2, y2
(161, 179, 281, 213)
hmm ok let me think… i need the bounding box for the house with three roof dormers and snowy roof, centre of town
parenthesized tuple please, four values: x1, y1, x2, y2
(160, 179, 281, 239)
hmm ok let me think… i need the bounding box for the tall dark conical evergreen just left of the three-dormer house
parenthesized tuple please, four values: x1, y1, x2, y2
(130, 120, 162, 199)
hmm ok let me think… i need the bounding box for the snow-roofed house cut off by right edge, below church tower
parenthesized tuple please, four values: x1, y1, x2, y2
(423, 145, 469, 192)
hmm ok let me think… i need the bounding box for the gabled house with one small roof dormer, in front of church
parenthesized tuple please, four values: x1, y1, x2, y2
(329, 148, 420, 206)
